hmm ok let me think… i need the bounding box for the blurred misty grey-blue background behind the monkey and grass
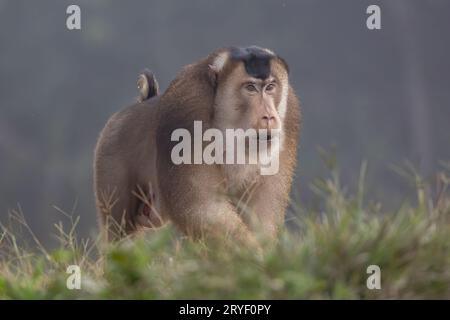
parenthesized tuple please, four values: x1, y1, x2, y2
(0, 0, 450, 243)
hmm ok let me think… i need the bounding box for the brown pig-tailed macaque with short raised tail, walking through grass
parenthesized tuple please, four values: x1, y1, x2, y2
(94, 46, 300, 246)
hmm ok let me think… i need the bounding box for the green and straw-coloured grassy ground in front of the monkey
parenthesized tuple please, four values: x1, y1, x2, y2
(0, 162, 450, 299)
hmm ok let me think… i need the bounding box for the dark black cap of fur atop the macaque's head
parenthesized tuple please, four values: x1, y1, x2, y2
(230, 46, 276, 80)
